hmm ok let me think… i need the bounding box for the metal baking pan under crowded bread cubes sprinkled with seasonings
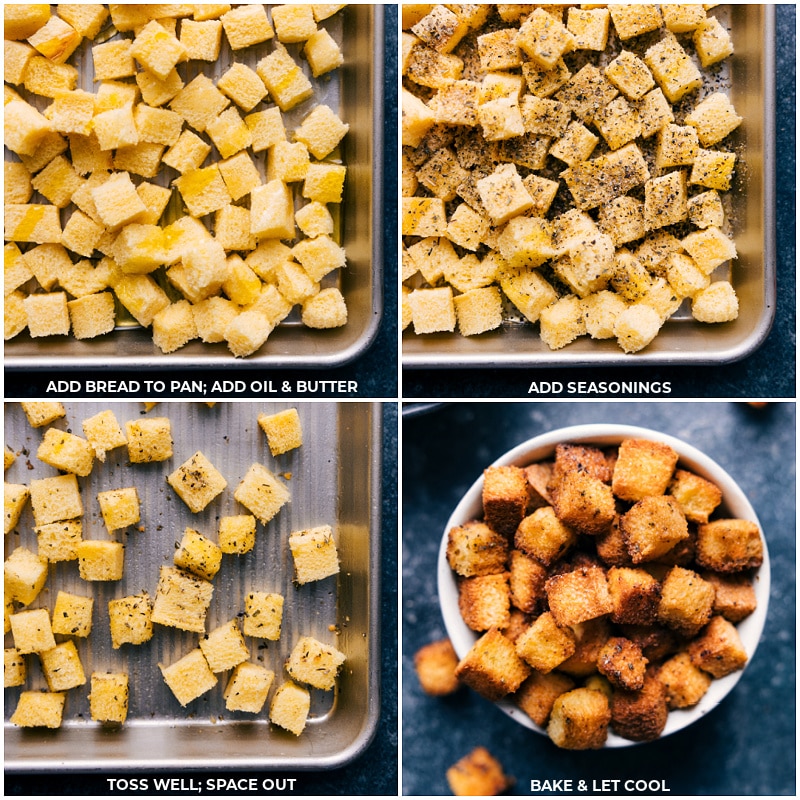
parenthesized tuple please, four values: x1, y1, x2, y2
(402, 4, 777, 368)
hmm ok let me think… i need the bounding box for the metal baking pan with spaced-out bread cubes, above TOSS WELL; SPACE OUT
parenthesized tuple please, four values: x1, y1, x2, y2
(4, 401, 381, 772)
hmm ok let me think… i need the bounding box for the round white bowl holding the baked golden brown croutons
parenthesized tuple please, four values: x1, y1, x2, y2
(437, 424, 770, 747)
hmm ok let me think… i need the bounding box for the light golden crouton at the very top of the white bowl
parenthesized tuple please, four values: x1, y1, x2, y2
(611, 439, 678, 503)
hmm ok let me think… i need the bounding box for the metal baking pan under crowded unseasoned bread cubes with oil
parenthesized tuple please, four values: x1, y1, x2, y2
(5, 5, 384, 370)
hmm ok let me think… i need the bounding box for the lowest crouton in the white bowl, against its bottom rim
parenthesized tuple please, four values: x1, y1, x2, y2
(547, 688, 611, 750)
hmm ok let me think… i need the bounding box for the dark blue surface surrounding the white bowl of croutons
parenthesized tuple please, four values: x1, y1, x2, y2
(402, 402, 796, 796)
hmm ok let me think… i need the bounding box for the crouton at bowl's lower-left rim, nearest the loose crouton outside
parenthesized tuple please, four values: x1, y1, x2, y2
(456, 628, 531, 700)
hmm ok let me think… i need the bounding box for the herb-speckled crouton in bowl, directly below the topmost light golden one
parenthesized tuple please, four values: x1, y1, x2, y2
(620, 496, 689, 564)
